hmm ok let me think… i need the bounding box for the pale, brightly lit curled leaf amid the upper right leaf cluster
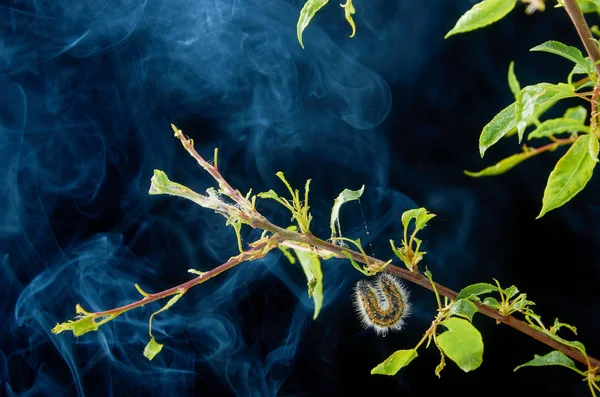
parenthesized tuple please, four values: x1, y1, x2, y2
(515, 83, 575, 142)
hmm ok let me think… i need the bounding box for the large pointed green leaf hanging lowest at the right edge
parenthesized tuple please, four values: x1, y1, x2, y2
(537, 134, 598, 219)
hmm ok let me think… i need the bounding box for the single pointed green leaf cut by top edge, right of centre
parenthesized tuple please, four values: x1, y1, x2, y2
(444, 0, 517, 39)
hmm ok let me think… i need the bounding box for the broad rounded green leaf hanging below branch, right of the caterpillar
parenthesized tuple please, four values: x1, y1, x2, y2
(437, 317, 483, 372)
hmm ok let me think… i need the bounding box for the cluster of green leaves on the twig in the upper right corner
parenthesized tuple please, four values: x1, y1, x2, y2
(446, 0, 600, 218)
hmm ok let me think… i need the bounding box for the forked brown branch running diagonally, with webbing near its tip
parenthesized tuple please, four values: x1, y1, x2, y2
(52, 126, 600, 368)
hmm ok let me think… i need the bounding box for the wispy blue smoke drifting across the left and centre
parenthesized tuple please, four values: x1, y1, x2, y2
(0, 0, 441, 396)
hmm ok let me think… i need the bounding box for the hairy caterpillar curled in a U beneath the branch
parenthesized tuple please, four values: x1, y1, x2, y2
(354, 273, 410, 336)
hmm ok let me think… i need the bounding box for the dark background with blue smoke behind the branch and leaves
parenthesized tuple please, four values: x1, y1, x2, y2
(0, 0, 600, 396)
